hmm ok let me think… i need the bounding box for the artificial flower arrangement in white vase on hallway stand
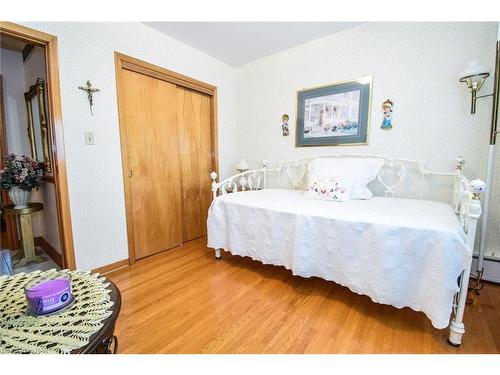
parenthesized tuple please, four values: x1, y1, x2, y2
(0, 154, 45, 208)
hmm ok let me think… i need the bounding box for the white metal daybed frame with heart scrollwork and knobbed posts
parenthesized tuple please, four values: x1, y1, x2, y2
(210, 155, 486, 345)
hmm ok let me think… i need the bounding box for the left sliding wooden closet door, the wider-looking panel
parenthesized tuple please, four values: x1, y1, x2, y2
(121, 70, 182, 259)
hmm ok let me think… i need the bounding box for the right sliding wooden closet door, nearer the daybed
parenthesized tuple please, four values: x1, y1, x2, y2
(177, 87, 212, 241)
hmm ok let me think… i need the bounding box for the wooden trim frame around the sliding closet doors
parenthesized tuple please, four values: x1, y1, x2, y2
(115, 52, 219, 265)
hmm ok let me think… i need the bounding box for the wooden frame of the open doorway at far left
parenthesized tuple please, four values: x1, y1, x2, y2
(0, 21, 76, 269)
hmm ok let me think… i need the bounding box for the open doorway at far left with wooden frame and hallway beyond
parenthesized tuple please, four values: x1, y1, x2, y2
(0, 22, 75, 272)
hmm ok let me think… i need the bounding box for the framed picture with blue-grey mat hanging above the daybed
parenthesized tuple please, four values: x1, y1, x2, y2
(296, 77, 372, 147)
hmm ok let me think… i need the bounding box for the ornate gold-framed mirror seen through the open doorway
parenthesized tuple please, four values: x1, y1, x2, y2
(24, 78, 52, 173)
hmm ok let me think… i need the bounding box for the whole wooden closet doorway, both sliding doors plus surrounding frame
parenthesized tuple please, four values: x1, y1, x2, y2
(115, 53, 217, 264)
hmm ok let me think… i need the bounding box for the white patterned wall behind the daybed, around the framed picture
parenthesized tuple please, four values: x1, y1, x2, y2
(237, 23, 500, 253)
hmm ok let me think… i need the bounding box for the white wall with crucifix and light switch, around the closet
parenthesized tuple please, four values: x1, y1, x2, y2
(19, 22, 236, 269)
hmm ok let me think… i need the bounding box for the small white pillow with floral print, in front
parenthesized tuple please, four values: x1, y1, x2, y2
(304, 177, 355, 202)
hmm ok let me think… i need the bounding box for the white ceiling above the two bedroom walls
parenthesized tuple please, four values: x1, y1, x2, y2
(144, 22, 362, 66)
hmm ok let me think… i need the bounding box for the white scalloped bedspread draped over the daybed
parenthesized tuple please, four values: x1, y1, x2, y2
(208, 189, 472, 328)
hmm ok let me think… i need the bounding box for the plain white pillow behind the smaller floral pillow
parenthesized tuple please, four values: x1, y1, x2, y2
(308, 157, 384, 199)
